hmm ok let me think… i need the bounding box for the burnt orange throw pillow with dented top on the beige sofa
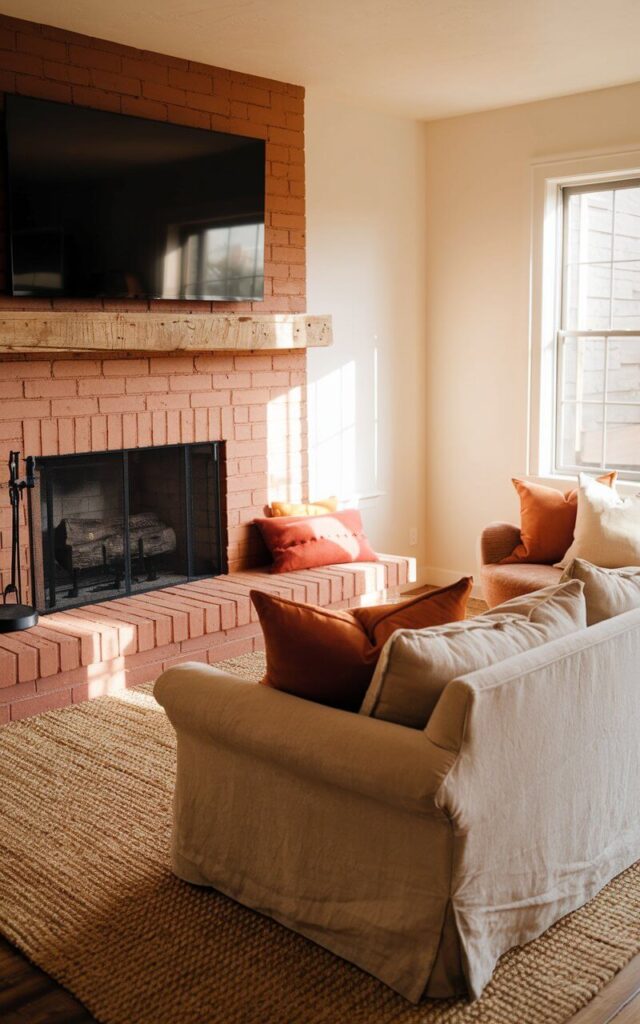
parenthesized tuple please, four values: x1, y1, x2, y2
(251, 578, 472, 711)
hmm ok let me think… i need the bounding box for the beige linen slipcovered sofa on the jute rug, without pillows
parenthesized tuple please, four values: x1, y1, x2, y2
(156, 610, 640, 1001)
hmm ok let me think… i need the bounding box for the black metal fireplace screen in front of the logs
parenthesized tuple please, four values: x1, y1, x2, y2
(31, 443, 225, 611)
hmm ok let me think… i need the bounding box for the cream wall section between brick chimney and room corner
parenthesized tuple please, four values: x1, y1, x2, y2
(305, 91, 427, 577)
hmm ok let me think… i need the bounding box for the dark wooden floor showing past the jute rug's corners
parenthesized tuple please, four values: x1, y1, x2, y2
(0, 937, 640, 1024)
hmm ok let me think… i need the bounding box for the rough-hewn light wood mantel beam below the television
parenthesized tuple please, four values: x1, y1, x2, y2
(0, 310, 332, 354)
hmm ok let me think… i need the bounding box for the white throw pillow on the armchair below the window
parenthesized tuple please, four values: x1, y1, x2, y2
(558, 473, 640, 569)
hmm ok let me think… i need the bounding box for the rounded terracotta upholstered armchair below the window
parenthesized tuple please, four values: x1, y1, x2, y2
(480, 522, 562, 608)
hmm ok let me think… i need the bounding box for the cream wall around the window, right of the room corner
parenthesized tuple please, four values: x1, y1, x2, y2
(423, 84, 640, 582)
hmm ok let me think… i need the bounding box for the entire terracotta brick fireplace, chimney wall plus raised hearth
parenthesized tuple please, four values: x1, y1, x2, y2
(0, 16, 413, 723)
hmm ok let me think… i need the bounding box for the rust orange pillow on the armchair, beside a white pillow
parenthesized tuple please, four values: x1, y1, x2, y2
(503, 472, 617, 565)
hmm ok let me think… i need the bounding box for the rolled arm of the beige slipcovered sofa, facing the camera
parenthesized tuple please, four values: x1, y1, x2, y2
(154, 664, 456, 816)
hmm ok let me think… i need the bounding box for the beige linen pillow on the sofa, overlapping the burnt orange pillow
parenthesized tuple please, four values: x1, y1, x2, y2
(360, 580, 587, 729)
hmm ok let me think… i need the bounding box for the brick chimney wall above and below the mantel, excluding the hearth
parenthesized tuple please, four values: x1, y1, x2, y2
(0, 16, 306, 598)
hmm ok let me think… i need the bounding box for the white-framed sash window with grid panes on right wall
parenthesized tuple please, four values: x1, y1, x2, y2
(554, 178, 640, 478)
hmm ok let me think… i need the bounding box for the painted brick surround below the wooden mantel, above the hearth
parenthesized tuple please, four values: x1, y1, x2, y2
(0, 351, 307, 587)
